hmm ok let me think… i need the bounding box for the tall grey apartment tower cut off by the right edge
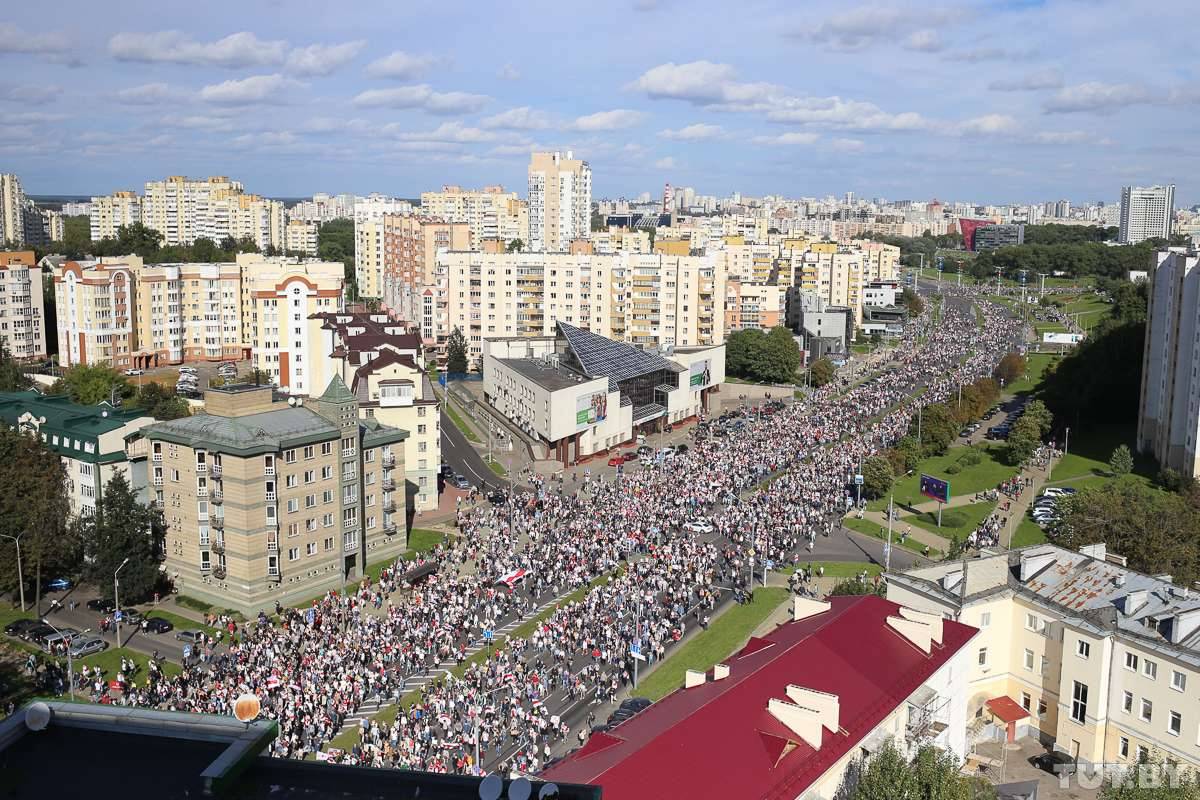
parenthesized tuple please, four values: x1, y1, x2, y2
(1138, 247, 1200, 477)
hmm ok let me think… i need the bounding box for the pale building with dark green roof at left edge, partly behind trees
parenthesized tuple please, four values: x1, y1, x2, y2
(0, 391, 155, 516)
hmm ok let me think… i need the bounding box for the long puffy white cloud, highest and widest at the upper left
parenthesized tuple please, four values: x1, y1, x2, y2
(108, 30, 288, 67)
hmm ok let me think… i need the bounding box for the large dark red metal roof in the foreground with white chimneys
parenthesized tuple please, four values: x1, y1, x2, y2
(541, 595, 977, 800)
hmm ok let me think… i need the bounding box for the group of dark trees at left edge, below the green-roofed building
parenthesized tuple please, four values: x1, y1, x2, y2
(0, 429, 166, 607)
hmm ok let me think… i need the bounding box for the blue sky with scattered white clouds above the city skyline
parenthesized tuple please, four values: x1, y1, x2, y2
(0, 0, 1200, 205)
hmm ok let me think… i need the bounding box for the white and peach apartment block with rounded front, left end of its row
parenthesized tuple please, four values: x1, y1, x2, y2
(54, 255, 142, 369)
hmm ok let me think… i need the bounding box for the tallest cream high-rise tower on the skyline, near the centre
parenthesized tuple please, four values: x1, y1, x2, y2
(528, 150, 592, 253)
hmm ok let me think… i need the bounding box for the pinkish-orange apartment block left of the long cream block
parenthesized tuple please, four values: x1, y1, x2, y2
(380, 215, 468, 326)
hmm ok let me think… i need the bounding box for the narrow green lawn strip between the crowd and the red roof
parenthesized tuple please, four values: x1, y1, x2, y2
(632, 587, 787, 700)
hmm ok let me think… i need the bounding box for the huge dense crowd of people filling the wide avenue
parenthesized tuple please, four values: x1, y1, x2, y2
(32, 291, 1018, 774)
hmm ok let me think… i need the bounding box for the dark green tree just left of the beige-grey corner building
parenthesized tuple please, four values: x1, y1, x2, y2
(74, 471, 167, 604)
